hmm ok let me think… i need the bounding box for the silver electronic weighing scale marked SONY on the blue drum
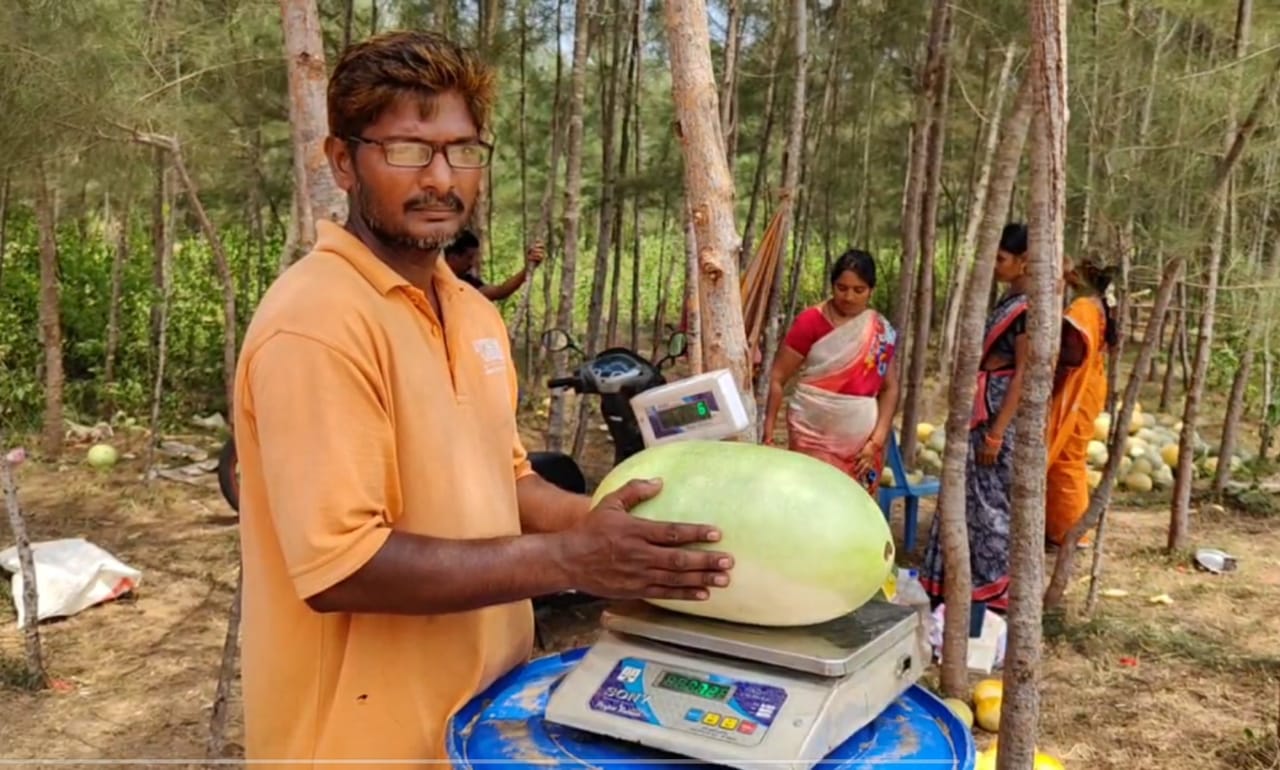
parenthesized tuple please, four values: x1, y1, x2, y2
(545, 601, 927, 770)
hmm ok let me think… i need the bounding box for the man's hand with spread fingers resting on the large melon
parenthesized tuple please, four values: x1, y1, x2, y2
(556, 480, 733, 600)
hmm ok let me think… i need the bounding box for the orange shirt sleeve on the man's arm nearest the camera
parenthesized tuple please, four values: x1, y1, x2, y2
(247, 333, 399, 599)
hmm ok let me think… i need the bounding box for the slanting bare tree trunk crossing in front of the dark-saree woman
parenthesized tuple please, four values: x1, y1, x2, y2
(938, 77, 1033, 697)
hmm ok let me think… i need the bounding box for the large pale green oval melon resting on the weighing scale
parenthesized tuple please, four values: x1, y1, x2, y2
(595, 441, 893, 627)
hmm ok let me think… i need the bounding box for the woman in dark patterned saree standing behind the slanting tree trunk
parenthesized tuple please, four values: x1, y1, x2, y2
(920, 224, 1027, 611)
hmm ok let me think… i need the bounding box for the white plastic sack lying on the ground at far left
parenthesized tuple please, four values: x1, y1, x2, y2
(0, 537, 142, 628)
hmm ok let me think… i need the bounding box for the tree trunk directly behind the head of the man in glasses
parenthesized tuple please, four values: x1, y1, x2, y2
(280, 0, 347, 253)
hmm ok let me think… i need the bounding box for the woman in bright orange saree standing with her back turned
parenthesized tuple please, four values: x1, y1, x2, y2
(1044, 258, 1119, 546)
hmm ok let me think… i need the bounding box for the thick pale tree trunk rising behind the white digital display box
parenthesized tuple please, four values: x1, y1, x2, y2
(663, 0, 755, 422)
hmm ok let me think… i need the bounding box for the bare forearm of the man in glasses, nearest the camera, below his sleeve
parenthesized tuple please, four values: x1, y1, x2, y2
(307, 532, 572, 615)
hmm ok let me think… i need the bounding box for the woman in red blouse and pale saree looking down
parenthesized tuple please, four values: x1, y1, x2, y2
(764, 249, 899, 495)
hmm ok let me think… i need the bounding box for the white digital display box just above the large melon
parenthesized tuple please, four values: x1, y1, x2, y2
(631, 368, 748, 446)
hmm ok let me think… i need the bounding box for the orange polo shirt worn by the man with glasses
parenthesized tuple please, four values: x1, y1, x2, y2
(234, 221, 532, 767)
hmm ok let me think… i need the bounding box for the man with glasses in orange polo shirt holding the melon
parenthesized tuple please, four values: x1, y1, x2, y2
(234, 32, 732, 767)
